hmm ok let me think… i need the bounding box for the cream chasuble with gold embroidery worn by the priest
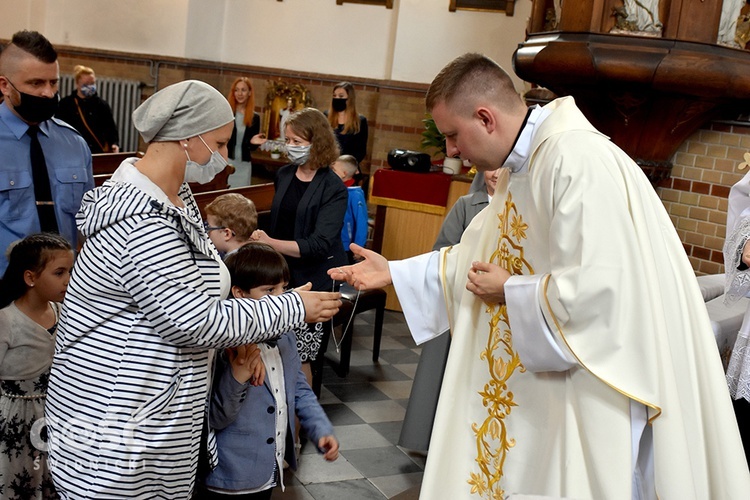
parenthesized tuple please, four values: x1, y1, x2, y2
(421, 98, 750, 500)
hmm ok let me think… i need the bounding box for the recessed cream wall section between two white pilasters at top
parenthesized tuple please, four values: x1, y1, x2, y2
(223, 0, 398, 79)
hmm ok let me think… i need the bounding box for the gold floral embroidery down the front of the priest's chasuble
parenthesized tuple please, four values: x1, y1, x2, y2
(467, 193, 534, 499)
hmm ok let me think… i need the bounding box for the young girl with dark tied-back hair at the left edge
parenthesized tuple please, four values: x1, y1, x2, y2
(0, 233, 73, 499)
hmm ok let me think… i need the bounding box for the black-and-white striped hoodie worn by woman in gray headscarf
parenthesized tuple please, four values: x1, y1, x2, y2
(46, 159, 304, 499)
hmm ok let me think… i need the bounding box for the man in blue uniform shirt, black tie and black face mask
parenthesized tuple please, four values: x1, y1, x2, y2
(0, 31, 94, 274)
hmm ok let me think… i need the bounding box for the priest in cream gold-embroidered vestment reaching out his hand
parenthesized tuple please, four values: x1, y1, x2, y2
(329, 54, 750, 500)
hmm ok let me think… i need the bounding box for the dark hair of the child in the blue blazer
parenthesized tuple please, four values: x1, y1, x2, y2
(224, 241, 289, 291)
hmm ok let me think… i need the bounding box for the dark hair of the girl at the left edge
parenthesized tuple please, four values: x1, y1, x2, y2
(0, 233, 73, 308)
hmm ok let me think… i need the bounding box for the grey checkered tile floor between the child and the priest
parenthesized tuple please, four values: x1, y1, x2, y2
(272, 311, 425, 500)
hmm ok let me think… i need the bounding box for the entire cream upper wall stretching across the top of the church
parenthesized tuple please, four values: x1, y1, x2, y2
(0, 0, 531, 83)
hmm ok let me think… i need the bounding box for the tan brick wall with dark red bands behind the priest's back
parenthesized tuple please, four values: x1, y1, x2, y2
(657, 122, 750, 275)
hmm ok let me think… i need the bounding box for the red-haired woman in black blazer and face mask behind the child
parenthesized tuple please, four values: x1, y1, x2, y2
(253, 108, 348, 383)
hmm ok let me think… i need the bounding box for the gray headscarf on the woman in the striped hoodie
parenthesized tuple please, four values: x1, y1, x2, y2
(133, 80, 234, 143)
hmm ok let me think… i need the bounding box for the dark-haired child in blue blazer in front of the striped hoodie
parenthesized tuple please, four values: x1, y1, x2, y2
(201, 243, 339, 500)
